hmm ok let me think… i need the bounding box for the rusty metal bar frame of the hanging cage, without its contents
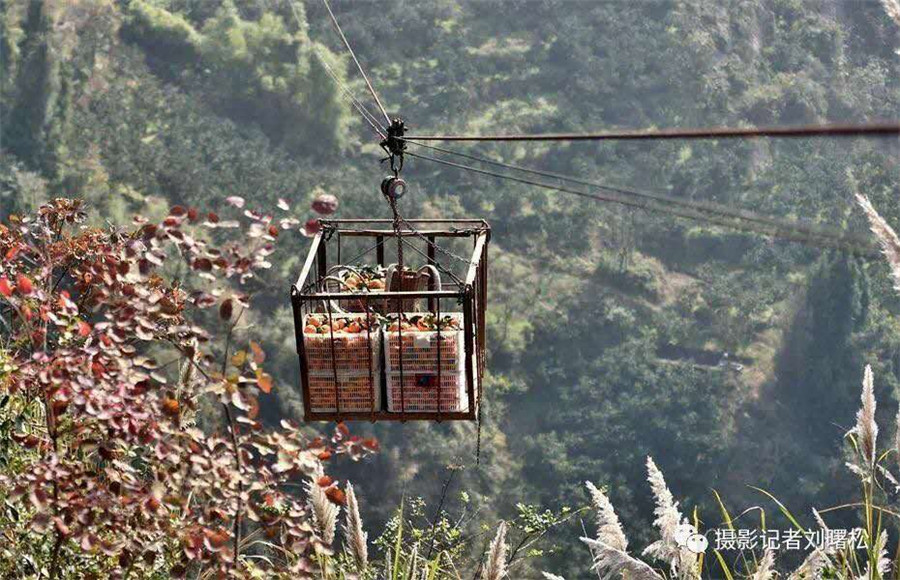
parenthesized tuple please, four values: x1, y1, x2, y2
(291, 219, 491, 422)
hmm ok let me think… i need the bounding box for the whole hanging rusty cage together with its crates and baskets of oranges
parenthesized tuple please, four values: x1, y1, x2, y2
(291, 220, 490, 421)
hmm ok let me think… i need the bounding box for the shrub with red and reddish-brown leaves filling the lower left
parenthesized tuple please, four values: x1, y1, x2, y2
(0, 199, 376, 578)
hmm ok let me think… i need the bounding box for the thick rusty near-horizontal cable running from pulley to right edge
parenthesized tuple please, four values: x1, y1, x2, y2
(406, 122, 900, 141)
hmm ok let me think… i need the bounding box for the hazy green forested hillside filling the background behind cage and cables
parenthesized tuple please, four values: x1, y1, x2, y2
(0, 0, 900, 578)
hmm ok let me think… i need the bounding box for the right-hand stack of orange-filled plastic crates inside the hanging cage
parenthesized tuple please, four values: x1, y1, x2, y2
(383, 315, 469, 413)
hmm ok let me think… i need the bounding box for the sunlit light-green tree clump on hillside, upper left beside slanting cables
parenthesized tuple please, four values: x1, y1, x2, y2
(123, 0, 347, 155)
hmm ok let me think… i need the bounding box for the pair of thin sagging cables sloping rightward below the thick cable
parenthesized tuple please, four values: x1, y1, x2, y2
(407, 152, 878, 256)
